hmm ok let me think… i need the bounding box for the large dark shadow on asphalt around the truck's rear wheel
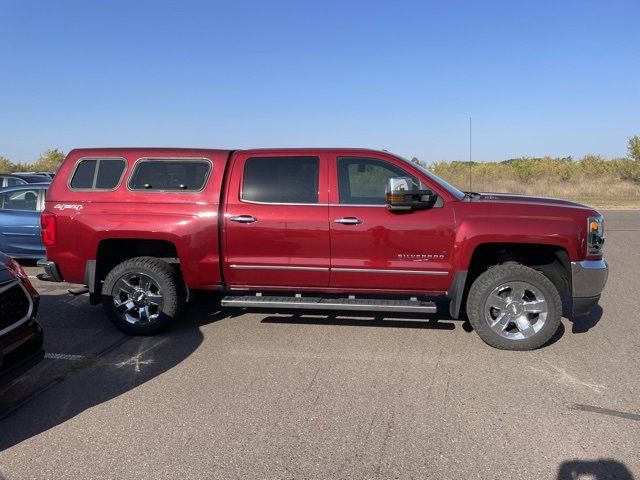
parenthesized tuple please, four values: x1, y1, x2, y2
(0, 293, 238, 451)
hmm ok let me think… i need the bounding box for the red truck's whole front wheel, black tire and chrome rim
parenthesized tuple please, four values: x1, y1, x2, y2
(467, 263, 562, 350)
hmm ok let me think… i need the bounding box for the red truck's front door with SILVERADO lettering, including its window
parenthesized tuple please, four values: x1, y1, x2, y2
(329, 156, 455, 294)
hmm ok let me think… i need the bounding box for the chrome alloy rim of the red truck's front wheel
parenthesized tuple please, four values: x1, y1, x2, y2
(484, 281, 549, 340)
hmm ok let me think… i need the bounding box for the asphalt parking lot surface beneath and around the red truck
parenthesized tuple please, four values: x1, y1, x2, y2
(0, 211, 640, 480)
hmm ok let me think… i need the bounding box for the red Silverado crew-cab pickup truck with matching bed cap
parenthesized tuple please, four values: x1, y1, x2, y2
(41, 148, 608, 350)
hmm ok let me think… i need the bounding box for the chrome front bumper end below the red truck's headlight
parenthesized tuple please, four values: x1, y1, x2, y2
(571, 260, 609, 316)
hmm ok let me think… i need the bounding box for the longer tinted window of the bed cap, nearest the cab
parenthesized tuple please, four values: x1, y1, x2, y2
(129, 159, 211, 192)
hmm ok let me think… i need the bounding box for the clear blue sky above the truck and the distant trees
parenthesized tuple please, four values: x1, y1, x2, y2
(0, 0, 640, 162)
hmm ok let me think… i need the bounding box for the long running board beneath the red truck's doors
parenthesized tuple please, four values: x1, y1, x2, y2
(220, 295, 437, 313)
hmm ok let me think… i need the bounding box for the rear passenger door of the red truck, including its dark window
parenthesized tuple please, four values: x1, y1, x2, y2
(223, 151, 330, 289)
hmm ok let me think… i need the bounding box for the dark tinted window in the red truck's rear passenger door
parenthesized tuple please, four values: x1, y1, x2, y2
(242, 157, 320, 204)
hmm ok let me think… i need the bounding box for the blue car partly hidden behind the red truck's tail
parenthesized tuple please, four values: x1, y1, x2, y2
(0, 188, 44, 257)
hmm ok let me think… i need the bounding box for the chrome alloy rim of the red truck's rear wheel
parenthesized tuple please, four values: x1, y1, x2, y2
(111, 273, 164, 325)
